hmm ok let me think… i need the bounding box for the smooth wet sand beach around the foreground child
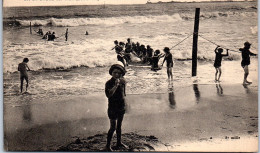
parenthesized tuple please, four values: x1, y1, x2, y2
(4, 84, 258, 152)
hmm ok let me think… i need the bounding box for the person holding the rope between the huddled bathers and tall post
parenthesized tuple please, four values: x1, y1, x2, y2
(162, 47, 173, 80)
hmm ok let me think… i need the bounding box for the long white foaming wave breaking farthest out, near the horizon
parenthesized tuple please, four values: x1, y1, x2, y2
(7, 11, 257, 27)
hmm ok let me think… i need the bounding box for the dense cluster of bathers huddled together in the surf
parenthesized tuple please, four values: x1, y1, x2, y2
(112, 38, 164, 71)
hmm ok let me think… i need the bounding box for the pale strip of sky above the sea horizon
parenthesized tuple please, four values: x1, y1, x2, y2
(3, 0, 250, 7)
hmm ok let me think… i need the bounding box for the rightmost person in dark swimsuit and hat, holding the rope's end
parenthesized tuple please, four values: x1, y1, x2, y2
(239, 42, 257, 85)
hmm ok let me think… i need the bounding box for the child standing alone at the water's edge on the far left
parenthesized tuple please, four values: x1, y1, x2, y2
(18, 58, 30, 93)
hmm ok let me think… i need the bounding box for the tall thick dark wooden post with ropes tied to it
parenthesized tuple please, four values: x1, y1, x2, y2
(192, 8, 200, 76)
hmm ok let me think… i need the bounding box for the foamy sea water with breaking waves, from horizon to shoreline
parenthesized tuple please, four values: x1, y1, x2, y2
(3, 2, 258, 103)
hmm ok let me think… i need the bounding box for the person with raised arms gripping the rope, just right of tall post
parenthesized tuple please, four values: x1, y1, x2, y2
(214, 46, 228, 81)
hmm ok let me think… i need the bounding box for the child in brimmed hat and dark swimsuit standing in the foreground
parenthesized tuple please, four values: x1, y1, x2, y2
(105, 62, 127, 151)
